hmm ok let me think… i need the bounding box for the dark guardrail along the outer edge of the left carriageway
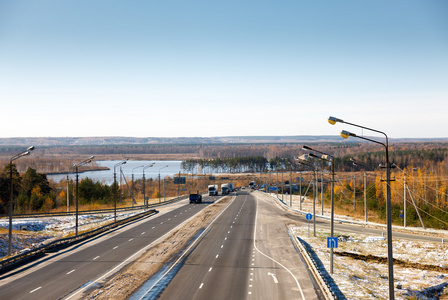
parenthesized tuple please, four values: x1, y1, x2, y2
(0, 209, 159, 274)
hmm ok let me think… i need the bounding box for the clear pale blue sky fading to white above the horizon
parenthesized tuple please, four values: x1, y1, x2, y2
(0, 0, 448, 138)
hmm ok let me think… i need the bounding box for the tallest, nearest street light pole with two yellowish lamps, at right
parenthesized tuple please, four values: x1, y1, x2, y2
(328, 117, 395, 300)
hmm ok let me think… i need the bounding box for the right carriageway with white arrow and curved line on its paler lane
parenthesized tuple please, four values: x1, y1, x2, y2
(149, 192, 318, 300)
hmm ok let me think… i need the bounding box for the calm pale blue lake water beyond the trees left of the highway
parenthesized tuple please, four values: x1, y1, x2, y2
(47, 160, 182, 185)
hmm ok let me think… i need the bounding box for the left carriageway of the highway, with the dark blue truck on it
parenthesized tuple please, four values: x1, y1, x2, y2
(0, 197, 219, 299)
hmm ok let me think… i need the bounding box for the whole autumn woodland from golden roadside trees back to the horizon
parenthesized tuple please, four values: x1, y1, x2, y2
(0, 141, 448, 228)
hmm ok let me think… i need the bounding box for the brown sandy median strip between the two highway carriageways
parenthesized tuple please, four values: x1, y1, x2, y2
(83, 196, 232, 299)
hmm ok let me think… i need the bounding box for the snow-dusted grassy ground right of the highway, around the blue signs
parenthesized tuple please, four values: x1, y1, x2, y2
(293, 226, 448, 299)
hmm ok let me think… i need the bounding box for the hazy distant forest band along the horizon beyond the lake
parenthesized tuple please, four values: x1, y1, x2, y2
(0, 142, 448, 173)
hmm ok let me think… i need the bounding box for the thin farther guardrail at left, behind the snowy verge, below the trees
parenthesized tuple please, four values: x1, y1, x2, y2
(0, 195, 188, 218)
